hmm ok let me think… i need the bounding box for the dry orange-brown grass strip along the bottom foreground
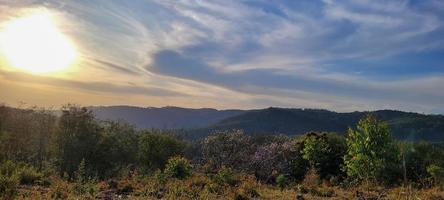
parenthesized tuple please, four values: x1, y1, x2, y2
(8, 173, 444, 200)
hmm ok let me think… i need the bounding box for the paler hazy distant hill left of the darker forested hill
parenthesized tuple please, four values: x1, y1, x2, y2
(89, 106, 244, 129)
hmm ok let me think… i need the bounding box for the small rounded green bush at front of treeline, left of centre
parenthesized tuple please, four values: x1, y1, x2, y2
(165, 156, 191, 179)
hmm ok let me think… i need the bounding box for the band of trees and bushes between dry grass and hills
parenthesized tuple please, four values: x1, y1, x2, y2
(0, 105, 444, 198)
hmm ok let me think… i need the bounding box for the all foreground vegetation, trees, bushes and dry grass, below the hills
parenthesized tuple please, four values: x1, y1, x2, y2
(0, 105, 444, 199)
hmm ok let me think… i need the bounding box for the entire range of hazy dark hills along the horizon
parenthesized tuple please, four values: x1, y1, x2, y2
(90, 106, 444, 141)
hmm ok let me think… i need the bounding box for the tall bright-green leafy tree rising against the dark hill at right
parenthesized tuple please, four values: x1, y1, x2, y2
(344, 115, 400, 184)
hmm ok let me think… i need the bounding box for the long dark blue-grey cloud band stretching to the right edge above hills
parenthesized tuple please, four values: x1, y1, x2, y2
(147, 51, 444, 107)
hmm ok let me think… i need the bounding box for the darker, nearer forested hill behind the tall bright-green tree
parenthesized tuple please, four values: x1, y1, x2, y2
(187, 108, 444, 141)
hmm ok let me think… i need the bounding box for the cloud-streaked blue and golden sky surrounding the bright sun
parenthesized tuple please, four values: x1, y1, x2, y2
(0, 0, 444, 114)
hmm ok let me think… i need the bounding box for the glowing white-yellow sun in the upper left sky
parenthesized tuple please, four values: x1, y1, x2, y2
(0, 11, 77, 73)
